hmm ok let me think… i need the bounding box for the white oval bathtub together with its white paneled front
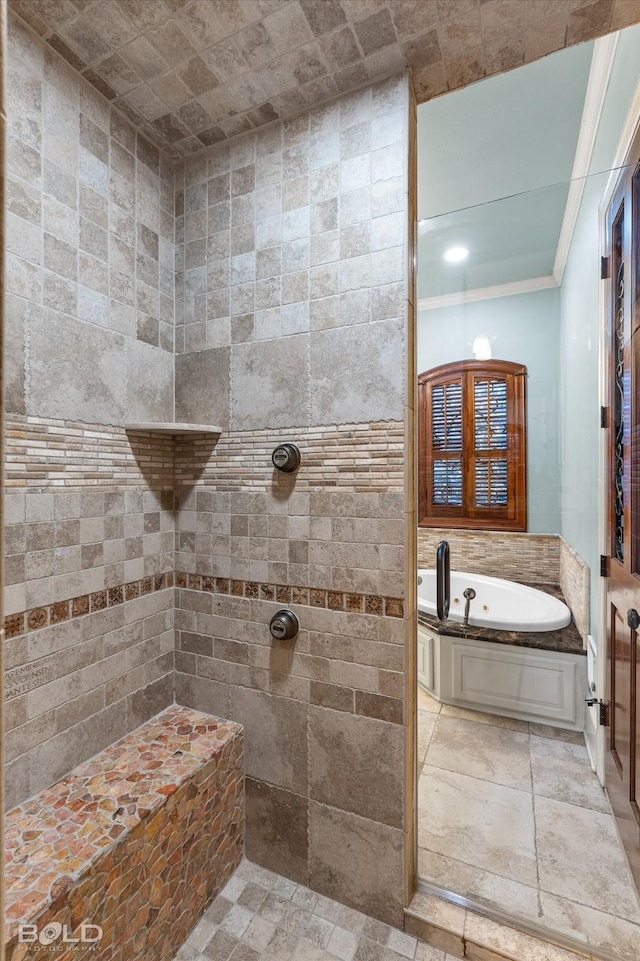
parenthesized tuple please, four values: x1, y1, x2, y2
(417, 570, 587, 731)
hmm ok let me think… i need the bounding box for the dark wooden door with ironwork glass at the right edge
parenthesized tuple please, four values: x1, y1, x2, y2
(605, 144, 640, 887)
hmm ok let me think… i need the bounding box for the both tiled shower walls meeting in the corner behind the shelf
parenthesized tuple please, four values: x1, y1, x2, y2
(6, 9, 412, 922)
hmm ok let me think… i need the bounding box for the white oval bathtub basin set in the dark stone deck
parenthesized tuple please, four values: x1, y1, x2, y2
(418, 570, 571, 632)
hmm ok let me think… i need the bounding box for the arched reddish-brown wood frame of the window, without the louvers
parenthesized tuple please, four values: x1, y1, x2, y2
(418, 360, 527, 531)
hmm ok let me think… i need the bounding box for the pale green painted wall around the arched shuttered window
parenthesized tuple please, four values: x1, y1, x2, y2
(418, 287, 560, 534)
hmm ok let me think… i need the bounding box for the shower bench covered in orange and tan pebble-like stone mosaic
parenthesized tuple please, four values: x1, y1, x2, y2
(4, 705, 244, 961)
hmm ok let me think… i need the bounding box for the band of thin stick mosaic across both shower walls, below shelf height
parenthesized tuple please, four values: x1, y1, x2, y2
(5, 416, 404, 491)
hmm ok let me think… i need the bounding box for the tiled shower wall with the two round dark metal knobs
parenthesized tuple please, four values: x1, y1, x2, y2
(170, 79, 409, 922)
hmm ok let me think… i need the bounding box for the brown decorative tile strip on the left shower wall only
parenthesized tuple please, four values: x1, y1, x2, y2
(5, 572, 174, 639)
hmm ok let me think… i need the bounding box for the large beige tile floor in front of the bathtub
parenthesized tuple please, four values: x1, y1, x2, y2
(418, 691, 640, 961)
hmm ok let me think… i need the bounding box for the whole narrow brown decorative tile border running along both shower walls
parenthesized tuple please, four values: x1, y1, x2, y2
(4, 571, 404, 640)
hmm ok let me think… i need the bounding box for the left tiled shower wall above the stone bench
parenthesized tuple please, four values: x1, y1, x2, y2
(5, 17, 174, 805)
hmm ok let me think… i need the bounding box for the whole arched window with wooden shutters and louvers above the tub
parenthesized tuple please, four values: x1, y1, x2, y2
(418, 360, 527, 531)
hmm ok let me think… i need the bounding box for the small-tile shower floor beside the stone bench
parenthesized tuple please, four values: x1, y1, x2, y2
(175, 860, 457, 961)
